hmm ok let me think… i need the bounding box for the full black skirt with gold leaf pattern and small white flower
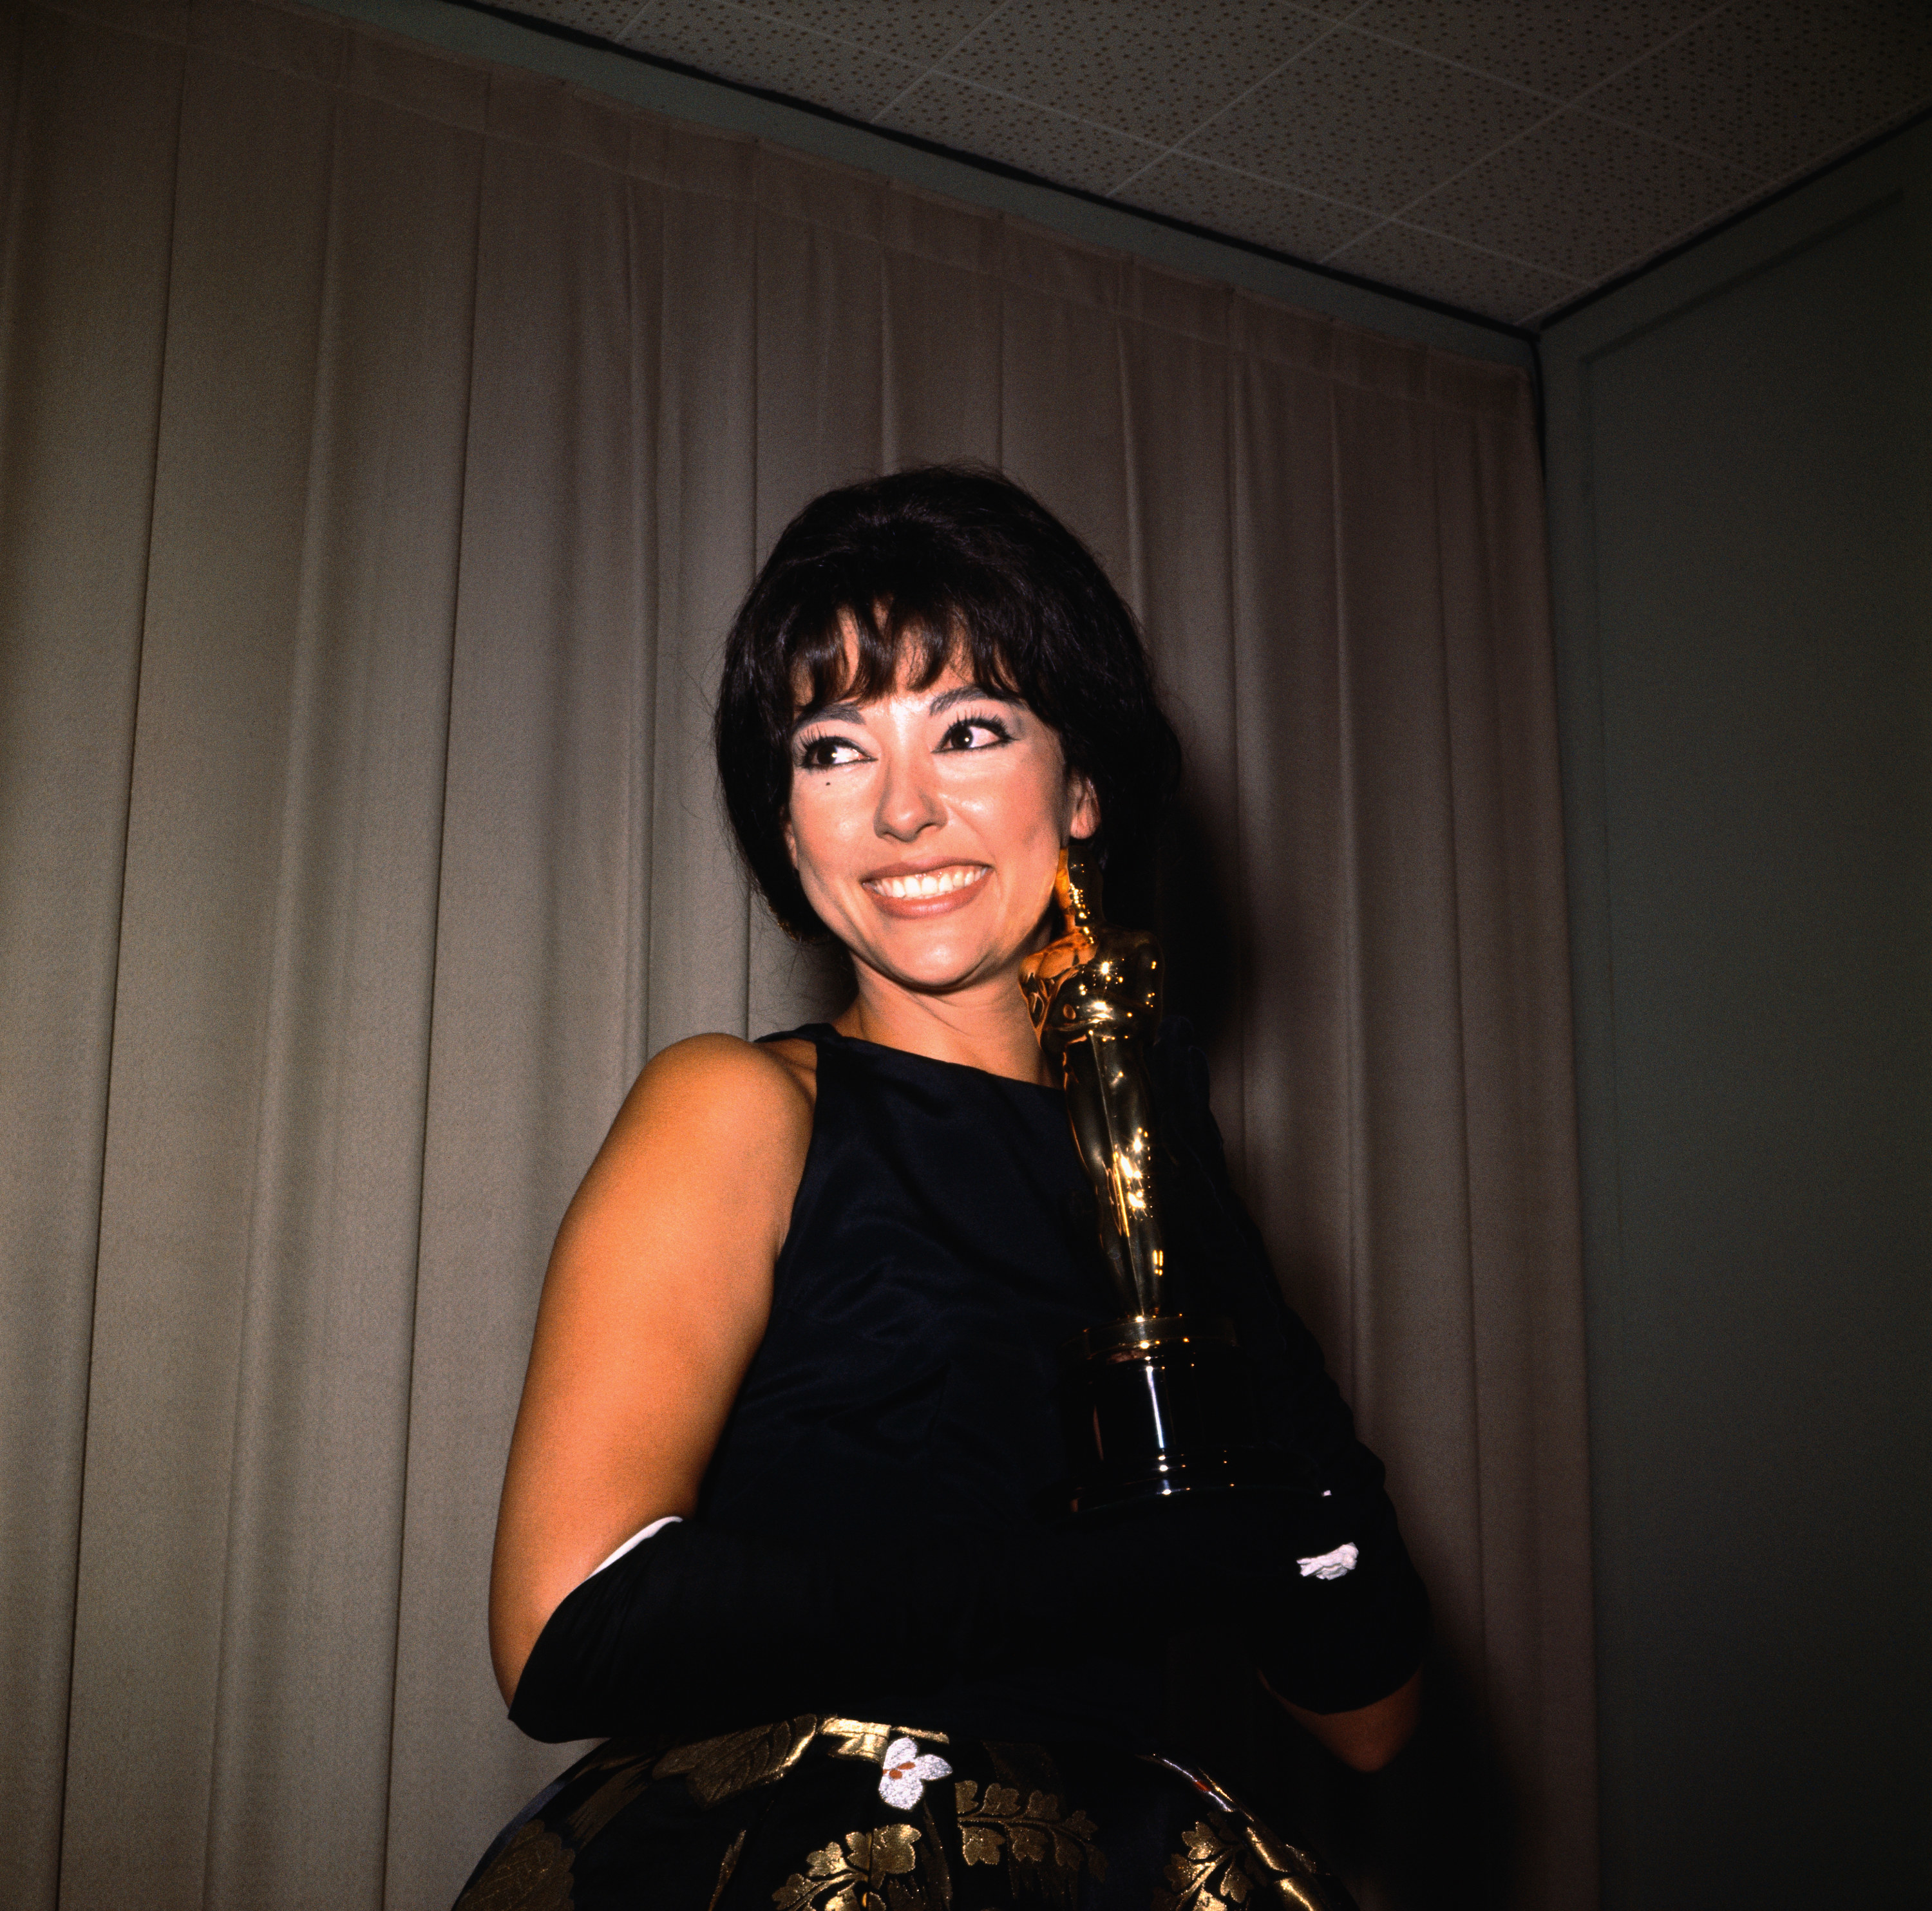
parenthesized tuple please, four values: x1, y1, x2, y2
(456, 1716, 1352, 1911)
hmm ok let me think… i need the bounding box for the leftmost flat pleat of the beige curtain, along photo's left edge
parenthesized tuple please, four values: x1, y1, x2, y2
(0, 10, 182, 1905)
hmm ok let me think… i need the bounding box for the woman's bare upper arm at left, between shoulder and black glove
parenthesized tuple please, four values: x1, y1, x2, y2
(489, 1036, 811, 1700)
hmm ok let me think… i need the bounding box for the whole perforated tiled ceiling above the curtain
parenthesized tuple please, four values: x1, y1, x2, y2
(504, 0, 1932, 326)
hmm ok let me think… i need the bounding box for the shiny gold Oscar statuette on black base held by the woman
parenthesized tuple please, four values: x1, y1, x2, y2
(1020, 850, 1296, 1513)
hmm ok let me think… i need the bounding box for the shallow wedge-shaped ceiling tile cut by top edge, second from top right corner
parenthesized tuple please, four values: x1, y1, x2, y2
(1349, 0, 1712, 100)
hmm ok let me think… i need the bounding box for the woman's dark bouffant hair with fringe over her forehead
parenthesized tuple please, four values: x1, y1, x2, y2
(715, 466, 1180, 937)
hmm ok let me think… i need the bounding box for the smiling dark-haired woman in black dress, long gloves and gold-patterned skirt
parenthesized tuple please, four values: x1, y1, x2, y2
(462, 469, 1424, 1911)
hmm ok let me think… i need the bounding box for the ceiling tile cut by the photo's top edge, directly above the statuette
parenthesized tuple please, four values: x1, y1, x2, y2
(945, 0, 1327, 147)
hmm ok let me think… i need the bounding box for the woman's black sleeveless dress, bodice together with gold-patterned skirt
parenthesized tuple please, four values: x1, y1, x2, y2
(458, 1024, 1360, 1911)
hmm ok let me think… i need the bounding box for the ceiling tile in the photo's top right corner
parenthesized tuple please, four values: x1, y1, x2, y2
(1588, 0, 1932, 180)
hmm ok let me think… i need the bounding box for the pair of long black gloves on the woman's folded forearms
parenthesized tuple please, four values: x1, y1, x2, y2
(510, 1494, 1414, 1743)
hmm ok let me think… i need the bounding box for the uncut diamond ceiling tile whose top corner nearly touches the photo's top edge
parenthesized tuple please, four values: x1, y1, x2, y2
(1184, 27, 1549, 212)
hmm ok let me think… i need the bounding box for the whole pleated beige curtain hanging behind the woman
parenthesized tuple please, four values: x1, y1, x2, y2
(0, 0, 1594, 1911)
